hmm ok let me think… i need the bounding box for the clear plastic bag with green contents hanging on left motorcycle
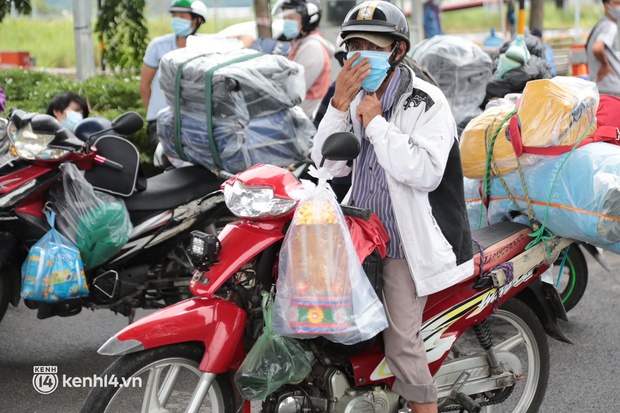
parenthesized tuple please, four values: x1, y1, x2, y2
(49, 163, 132, 269)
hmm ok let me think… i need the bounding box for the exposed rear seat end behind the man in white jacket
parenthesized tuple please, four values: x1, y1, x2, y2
(472, 222, 532, 277)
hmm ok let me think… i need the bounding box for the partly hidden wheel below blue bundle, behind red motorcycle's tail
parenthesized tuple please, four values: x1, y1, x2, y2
(553, 244, 588, 311)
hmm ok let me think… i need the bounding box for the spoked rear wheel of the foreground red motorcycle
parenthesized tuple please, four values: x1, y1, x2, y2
(440, 298, 550, 413)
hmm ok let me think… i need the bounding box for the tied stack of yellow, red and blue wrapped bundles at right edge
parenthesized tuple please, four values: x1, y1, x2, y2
(461, 77, 620, 253)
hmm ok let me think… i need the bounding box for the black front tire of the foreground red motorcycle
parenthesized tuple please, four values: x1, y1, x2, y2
(80, 343, 236, 413)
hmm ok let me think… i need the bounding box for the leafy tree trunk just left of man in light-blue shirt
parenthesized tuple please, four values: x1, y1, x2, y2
(95, 0, 148, 69)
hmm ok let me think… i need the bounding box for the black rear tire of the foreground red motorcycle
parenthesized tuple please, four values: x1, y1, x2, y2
(500, 298, 551, 413)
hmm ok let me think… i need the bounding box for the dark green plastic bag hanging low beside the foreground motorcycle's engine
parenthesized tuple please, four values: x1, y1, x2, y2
(235, 293, 314, 400)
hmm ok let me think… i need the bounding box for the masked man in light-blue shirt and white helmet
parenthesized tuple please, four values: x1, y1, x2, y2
(140, 0, 207, 150)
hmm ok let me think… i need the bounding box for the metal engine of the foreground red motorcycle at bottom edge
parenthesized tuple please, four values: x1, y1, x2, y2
(275, 368, 400, 413)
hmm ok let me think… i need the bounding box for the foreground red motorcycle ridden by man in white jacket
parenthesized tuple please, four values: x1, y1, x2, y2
(82, 134, 572, 413)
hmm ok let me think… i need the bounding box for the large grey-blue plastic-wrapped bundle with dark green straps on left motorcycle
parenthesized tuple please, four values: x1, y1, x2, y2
(157, 37, 316, 173)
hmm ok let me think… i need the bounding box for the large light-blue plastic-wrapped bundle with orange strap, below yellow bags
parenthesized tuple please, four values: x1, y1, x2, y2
(465, 142, 620, 253)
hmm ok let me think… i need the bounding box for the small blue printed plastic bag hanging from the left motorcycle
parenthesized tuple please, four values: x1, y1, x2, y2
(21, 211, 88, 303)
